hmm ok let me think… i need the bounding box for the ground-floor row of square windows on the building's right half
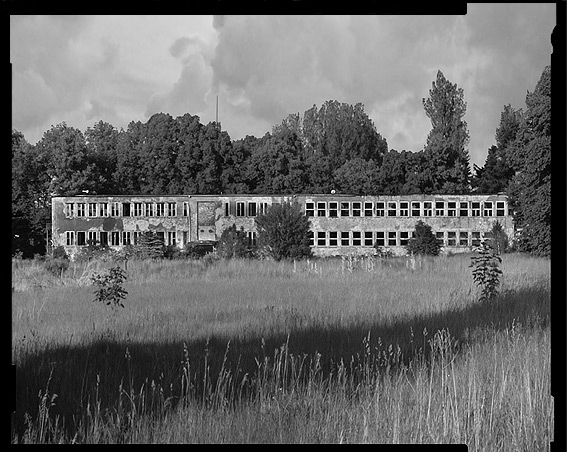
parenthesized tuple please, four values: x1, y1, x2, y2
(309, 231, 491, 246)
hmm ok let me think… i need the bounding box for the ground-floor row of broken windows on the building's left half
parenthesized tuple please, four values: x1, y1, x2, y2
(65, 231, 257, 246)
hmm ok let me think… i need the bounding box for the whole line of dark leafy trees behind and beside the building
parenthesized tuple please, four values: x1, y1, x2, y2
(12, 67, 551, 256)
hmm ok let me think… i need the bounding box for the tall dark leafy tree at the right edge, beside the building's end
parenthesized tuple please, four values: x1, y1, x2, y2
(508, 66, 551, 256)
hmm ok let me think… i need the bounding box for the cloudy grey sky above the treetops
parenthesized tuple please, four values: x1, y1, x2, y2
(10, 3, 556, 167)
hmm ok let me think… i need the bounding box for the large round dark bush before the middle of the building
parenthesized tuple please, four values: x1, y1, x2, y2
(255, 202, 312, 261)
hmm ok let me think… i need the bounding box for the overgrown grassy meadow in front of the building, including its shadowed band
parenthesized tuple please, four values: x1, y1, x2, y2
(12, 254, 554, 451)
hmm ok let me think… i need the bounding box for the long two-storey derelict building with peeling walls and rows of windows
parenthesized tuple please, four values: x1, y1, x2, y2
(51, 194, 514, 256)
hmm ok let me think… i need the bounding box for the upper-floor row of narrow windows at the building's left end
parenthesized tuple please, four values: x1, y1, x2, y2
(65, 202, 189, 217)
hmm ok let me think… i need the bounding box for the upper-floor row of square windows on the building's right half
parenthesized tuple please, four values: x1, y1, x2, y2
(305, 201, 506, 217)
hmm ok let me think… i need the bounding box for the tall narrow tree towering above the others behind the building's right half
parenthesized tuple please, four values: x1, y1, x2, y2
(423, 71, 470, 194)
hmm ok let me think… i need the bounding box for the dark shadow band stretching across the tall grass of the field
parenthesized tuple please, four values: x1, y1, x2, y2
(12, 287, 550, 435)
